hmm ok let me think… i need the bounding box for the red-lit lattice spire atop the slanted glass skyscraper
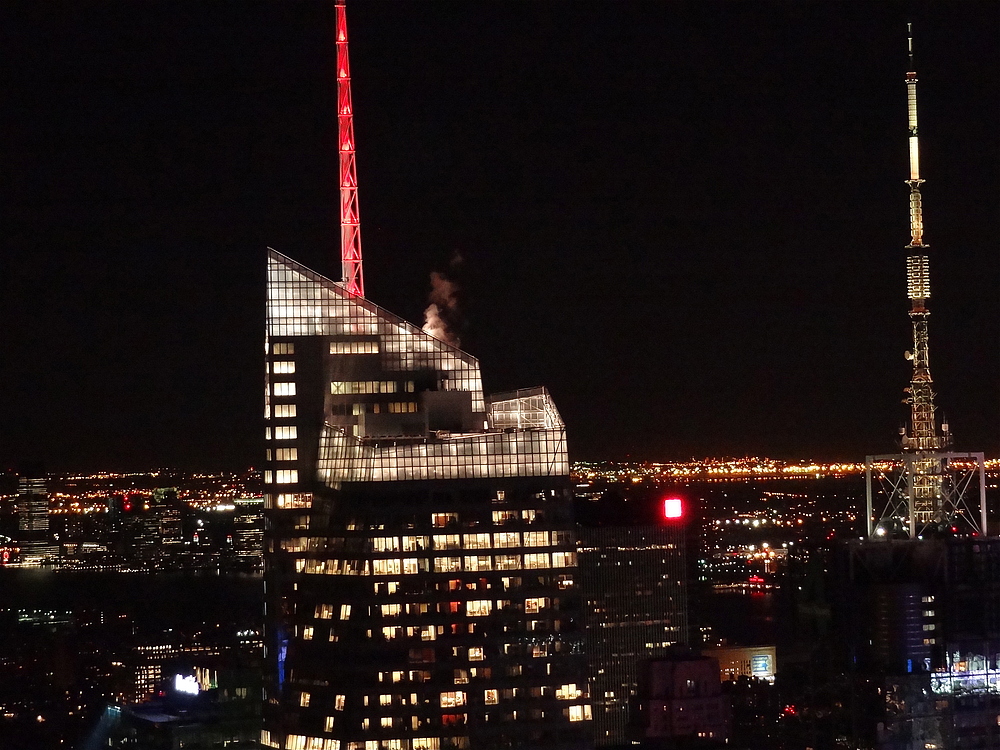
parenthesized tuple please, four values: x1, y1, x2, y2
(336, 0, 365, 297)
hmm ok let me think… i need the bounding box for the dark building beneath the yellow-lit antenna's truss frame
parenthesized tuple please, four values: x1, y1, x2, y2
(837, 537, 1000, 750)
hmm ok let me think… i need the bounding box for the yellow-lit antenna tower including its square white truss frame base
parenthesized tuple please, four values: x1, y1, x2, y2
(865, 24, 986, 539)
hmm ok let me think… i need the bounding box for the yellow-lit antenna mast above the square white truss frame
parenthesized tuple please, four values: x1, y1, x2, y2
(903, 24, 951, 451)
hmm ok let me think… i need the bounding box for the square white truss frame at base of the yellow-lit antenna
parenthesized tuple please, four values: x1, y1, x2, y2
(865, 451, 986, 539)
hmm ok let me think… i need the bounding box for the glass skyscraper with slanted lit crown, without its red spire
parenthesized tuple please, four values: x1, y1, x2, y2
(262, 251, 591, 750)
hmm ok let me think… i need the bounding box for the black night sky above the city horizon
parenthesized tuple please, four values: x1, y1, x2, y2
(0, 0, 1000, 470)
